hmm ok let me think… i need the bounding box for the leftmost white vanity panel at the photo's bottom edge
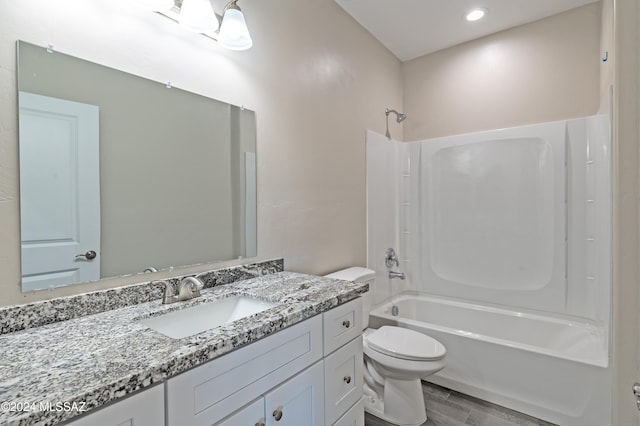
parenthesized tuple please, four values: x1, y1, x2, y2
(67, 385, 164, 426)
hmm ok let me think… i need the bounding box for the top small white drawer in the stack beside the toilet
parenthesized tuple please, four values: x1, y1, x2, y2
(323, 297, 362, 355)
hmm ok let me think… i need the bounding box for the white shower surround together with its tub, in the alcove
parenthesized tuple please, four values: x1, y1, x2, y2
(367, 116, 611, 426)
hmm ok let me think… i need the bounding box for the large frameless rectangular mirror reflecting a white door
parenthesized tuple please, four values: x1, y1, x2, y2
(18, 41, 257, 291)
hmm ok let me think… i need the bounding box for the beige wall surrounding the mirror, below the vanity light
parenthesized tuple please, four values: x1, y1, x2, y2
(0, 0, 402, 305)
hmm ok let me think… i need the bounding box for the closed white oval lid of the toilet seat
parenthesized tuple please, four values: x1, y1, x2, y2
(367, 325, 447, 361)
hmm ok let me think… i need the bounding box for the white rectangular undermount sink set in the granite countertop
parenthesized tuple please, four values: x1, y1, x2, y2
(139, 295, 277, 339)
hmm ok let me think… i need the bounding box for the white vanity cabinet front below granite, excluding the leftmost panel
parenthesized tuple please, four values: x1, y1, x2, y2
(166, 298, 364, 426)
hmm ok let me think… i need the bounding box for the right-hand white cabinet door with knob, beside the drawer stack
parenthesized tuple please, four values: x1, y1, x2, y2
(265, 361, 324, 426)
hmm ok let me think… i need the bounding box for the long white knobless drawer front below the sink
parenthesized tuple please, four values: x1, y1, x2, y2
(167, 315, 322, 426)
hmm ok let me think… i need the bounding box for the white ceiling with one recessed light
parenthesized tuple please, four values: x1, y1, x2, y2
(335, 0, 598, 61)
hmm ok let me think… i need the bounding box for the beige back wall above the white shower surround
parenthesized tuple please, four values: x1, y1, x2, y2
(402, 3, 601, 141)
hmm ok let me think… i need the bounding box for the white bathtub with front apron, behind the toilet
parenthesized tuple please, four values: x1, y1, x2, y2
(369, 292, 611, 426)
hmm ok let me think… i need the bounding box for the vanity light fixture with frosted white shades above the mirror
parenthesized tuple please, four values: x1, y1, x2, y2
(154, 0, 253, 50)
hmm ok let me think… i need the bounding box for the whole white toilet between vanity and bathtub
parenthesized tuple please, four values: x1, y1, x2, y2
(327, 267, 447, 425)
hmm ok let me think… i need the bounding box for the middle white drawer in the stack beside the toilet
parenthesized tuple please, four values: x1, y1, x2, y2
(324, 337, 364, 425)
